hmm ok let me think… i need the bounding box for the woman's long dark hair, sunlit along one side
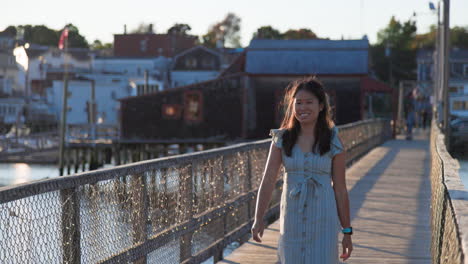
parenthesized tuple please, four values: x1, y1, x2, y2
(280, 76, 334, 157)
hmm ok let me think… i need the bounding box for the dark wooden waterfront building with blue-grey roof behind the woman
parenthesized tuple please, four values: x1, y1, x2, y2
(121, 40, 391, 141)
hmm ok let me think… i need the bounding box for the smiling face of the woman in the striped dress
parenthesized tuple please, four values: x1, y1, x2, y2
(293, 90, 323, 124)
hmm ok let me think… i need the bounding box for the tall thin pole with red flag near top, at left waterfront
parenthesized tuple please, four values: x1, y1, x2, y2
(59, 35, 68, 176)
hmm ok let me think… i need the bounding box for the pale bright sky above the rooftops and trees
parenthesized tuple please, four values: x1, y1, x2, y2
(0, 0, 468, 46)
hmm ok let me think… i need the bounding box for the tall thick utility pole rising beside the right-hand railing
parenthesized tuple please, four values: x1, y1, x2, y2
(442, 0, 450, 146)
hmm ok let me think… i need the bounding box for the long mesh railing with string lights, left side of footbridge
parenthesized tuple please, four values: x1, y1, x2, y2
(0, 120, 391, 263)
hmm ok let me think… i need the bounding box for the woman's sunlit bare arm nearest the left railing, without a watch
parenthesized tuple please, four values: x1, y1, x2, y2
(252, 142, 282, 242)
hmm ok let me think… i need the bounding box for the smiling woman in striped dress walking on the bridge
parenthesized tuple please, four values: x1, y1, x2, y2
(251, 77, 353, 264)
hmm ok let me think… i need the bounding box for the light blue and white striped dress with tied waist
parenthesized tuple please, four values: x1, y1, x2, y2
(270, 127, 343, 264)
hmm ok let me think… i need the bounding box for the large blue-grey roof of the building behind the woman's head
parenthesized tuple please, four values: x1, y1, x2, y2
(246, 39, 369, 75)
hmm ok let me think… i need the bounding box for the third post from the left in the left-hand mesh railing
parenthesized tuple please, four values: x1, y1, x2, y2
(179, 161, 196, 262)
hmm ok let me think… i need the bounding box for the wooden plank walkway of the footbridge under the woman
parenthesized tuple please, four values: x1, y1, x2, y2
(218, 131, 431, 264)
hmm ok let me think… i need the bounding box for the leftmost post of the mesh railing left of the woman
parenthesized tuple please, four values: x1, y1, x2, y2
(60, 188, 81, 264)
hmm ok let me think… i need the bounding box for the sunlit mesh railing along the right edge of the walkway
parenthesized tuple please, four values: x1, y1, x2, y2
(431, 121, 468, 264)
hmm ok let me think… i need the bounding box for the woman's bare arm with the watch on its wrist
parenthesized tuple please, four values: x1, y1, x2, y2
(332, 152, 353, 261)
